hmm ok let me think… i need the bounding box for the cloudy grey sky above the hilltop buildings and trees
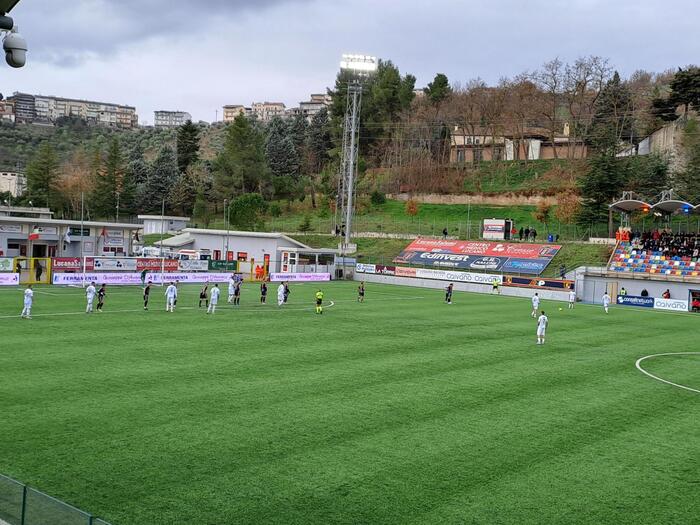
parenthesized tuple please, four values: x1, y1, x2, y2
(0, 0, 700, 122)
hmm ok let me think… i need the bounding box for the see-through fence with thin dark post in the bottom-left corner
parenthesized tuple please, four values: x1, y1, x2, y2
(0, 474, 109, 525)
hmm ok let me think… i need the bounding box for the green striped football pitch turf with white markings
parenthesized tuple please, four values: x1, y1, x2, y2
(0, 283, 700, 525)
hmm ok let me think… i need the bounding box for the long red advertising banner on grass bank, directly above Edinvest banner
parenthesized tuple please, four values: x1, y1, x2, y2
(404, 239, 561, 259)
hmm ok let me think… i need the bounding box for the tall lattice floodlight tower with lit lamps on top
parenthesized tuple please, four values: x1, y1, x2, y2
(338, 55, 377, 251)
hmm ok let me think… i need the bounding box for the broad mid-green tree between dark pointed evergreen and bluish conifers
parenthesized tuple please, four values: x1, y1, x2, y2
(212, 115, 269, 199)
